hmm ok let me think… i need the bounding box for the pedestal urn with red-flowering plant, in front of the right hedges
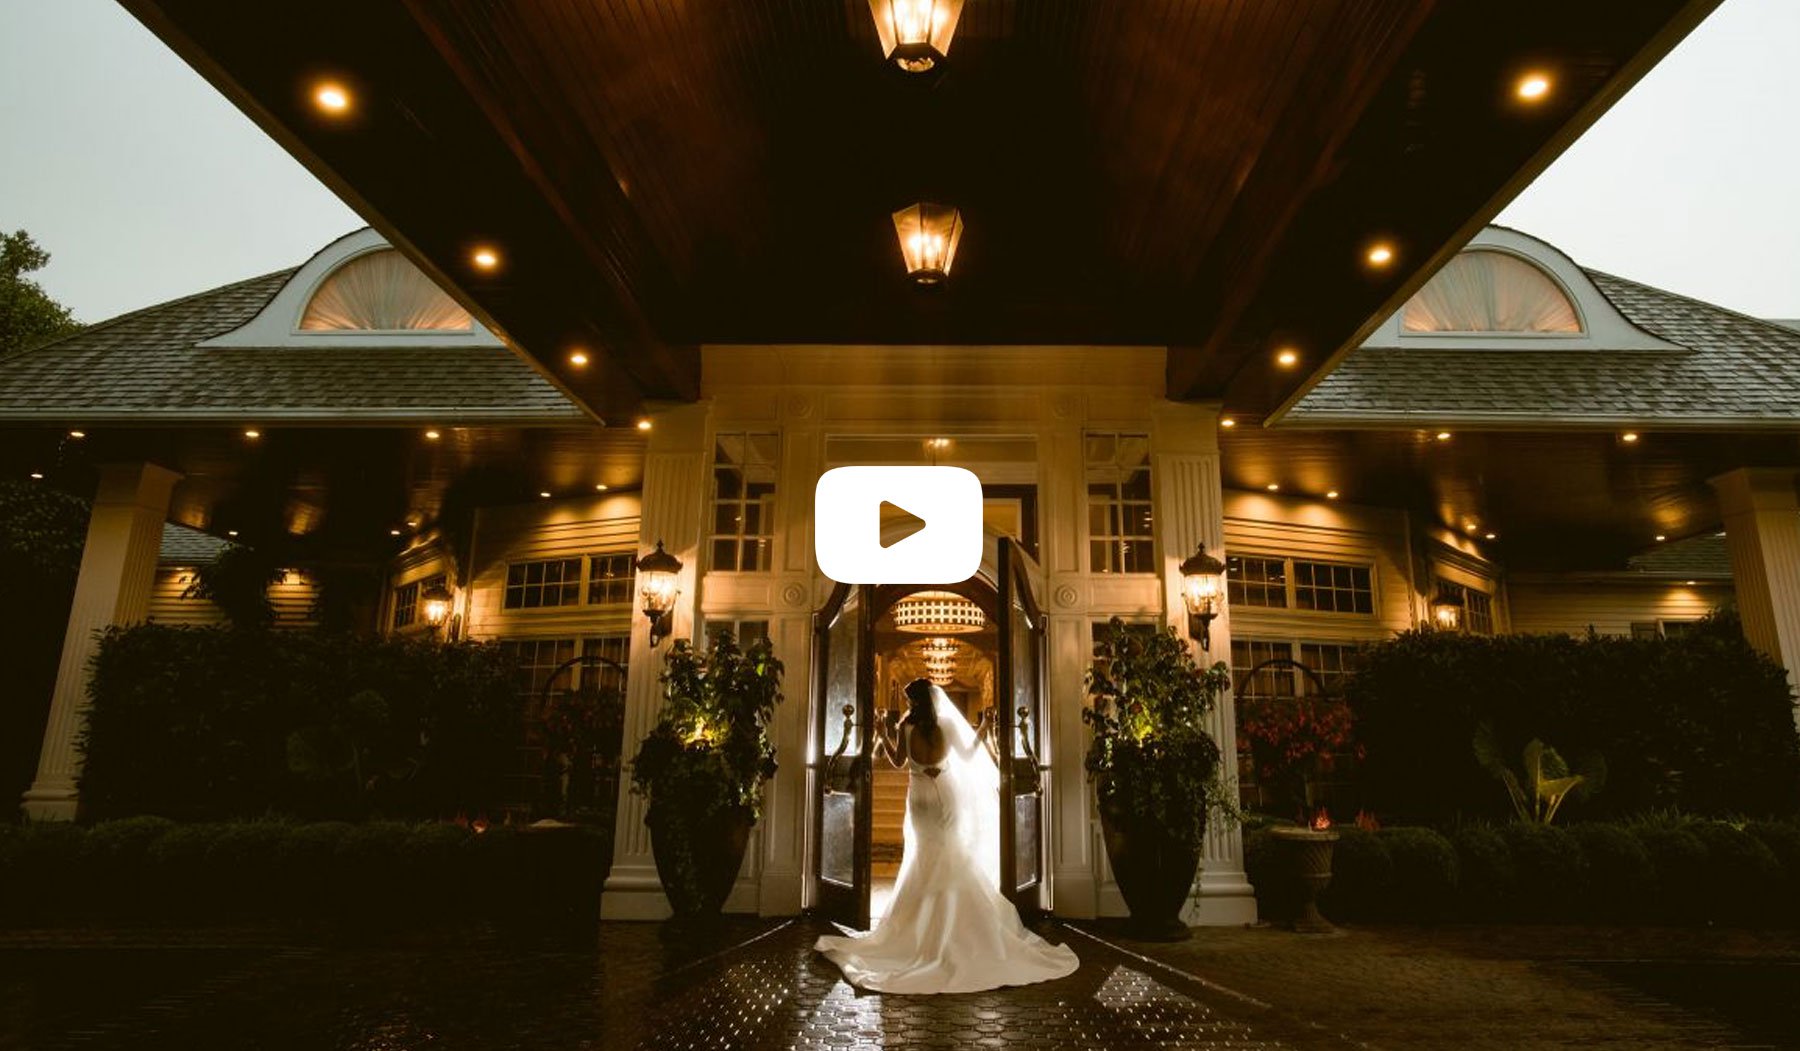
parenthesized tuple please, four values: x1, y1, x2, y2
(1238, 660, 1352, 934)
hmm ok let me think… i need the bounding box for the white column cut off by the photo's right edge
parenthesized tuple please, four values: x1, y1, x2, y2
(1712, 468, 1800, 720)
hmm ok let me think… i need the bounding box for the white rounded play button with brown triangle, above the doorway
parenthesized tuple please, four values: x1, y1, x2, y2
(812, 466, 981, 583)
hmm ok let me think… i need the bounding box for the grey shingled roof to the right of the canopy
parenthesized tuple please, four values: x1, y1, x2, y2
(1283, 262, 1800, 427)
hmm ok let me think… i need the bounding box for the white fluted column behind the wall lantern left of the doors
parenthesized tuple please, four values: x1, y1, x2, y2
(599, 403, 709, 920)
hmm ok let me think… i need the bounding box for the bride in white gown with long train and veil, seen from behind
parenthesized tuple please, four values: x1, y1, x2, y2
(814, 678, 1080, 993)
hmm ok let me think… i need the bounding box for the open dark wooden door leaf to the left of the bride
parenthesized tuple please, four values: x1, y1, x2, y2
(812, 585, 875, 930)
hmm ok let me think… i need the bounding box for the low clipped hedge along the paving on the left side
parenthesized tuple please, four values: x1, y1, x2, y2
(0, 817, 610, 932)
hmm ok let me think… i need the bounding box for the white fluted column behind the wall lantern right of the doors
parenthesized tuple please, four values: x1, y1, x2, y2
(1150, 401, 1256, 925)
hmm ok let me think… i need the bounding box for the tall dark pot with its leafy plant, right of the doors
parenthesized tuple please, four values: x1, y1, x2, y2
(1082, 617, 1237, 941)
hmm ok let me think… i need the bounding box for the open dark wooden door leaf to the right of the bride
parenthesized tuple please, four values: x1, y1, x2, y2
(994, 538, 1049, 920)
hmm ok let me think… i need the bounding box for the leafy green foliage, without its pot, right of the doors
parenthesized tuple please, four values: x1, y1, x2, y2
(1082, 617, 1238, 848)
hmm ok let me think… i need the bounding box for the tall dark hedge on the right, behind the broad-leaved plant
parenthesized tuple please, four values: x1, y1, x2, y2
(1346, 614, 1800, 828)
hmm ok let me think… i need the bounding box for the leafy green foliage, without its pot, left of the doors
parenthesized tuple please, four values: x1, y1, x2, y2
(632, 632, 783, 822)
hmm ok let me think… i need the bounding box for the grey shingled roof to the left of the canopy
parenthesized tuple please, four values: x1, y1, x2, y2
(0, 270, 589, 425)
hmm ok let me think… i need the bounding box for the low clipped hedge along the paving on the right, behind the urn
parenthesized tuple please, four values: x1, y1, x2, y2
(1244, 815, 1800, 927)
